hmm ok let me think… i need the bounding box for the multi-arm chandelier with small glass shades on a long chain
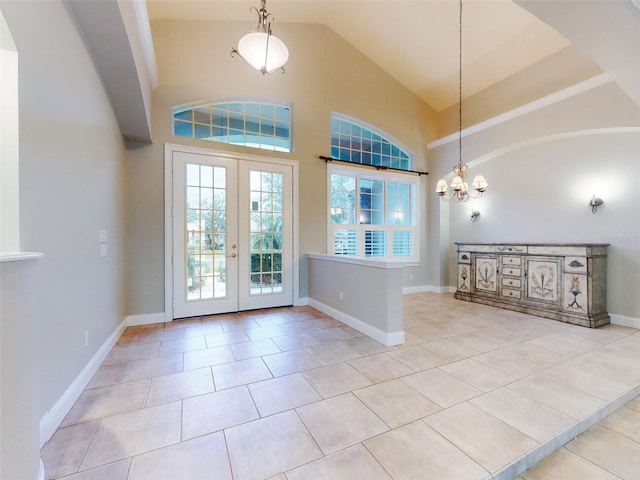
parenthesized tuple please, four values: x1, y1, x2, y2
(436, 0, 489, 202)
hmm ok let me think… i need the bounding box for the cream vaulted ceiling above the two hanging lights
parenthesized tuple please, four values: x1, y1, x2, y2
(147, 0, 570, 111)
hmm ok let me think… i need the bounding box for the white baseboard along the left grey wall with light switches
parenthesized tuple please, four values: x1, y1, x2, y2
(40, 319, 127, 448)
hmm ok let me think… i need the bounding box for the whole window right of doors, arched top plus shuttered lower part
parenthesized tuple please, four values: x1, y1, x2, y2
(327, 114, 420, 261)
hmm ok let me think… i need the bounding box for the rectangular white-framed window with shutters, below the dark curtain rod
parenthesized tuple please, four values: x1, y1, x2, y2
(328, 165, 420, 261)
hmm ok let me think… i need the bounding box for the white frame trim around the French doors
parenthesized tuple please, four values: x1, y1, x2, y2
(164, 143, 302, 322)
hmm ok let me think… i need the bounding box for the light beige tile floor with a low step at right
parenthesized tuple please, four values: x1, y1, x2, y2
(42, 293, 640, 480)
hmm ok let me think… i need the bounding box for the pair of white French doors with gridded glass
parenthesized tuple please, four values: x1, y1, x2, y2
(171, 151, 293, 318)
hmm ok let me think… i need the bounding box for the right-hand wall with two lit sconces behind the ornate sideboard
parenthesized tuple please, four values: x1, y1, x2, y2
(430, 82, 640, 320)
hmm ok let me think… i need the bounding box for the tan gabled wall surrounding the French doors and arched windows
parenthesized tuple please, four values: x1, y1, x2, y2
(127, 21, 435, 314)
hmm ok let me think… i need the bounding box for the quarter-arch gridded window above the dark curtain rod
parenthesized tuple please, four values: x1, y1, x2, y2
(331, 113, 413, 170)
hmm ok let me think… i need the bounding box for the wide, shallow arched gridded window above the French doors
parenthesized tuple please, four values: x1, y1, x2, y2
(173, 100, 291, 152)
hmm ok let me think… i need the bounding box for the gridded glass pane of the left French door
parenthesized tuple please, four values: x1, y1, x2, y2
(185, 164, 227, 301)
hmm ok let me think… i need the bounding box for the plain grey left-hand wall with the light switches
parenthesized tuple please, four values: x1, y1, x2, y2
(2, 1, 125, 428)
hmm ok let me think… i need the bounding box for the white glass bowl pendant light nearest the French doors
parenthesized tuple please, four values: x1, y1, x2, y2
(231, 0, 289, 75)
